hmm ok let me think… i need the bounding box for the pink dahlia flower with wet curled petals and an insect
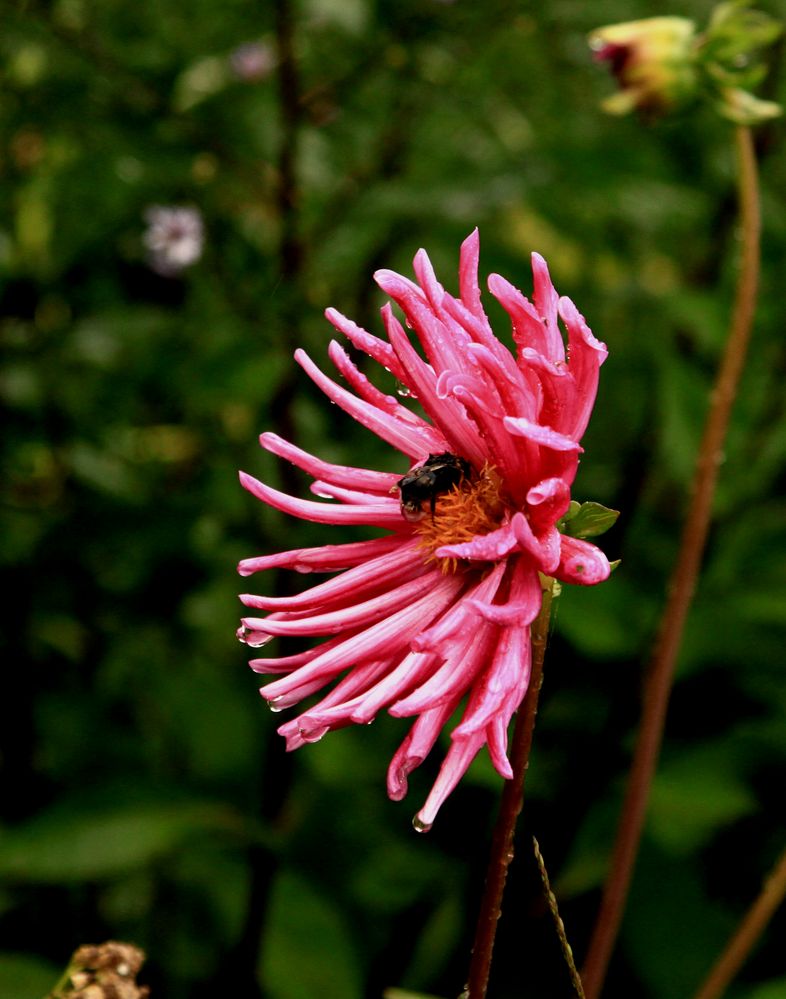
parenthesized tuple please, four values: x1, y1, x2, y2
(238, 232, 609, 830)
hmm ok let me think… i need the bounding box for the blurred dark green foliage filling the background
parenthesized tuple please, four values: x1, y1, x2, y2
(0, 0, 786, 999)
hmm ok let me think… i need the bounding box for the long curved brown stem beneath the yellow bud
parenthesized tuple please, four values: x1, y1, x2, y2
(582, 126, 761, 999)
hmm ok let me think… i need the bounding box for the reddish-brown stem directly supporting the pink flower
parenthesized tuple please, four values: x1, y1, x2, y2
(461, 589, 553, 999)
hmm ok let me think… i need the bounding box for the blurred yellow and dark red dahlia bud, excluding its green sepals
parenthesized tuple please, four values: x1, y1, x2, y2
(589, 17, 698, 115)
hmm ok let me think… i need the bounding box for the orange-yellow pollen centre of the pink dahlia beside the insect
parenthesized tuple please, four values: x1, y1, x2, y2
(415, 465, 509, 573)
